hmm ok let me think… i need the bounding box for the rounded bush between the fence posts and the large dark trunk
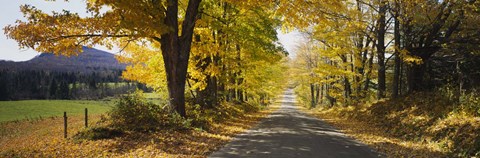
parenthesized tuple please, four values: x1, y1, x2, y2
(109, 92, 190, 131)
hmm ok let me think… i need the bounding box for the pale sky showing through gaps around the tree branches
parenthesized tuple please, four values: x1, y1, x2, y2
(0, 0, 303, 61)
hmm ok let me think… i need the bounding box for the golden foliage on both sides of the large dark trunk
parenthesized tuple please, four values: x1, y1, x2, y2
(4, 0, 288, 102)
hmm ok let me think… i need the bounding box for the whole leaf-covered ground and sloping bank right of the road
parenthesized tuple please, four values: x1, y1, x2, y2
(305, 94, 480, 157)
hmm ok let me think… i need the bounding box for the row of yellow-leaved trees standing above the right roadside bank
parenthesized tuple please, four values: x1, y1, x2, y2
(287, 0, 480, 107)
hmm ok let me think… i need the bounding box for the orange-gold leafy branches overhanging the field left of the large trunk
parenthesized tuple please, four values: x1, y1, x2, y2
(4, 0, 170, 56)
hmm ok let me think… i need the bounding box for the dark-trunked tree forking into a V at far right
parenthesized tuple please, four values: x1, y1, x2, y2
(402, 1, 472, 92)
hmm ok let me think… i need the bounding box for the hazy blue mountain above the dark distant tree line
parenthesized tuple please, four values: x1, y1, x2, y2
(0, 47, 126, 72)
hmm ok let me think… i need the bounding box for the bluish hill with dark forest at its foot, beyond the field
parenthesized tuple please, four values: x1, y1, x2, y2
(0, 47, 137, 100)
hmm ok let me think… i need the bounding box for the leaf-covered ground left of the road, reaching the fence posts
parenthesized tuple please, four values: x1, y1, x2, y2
(0, 101, 278, 157)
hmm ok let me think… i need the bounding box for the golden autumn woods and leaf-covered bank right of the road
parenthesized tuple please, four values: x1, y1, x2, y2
(284, 0, 480, 157)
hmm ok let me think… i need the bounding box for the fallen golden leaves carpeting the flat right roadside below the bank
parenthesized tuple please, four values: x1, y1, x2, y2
(305, 106, 446, 157)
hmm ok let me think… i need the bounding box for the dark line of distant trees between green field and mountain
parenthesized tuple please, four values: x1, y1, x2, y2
(0, 69, 148, 100)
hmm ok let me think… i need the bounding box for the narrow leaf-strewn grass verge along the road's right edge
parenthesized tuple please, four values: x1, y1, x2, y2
(308, 108, 448, 157)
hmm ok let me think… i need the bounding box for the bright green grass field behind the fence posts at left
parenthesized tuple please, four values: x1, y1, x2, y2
(0, 100, 114, 122)
